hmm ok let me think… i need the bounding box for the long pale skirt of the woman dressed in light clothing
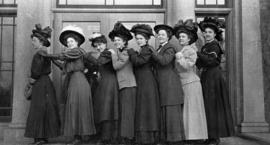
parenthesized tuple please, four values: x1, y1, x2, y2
(183, 81, 208, 140)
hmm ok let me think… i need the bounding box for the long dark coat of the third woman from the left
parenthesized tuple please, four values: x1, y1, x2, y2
(85, 49, 119, 124)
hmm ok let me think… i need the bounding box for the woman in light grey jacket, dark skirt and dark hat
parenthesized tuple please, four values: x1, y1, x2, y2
(109, 22, 136, 143)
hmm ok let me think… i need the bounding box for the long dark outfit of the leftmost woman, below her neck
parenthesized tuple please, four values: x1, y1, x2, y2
(25, 50, 60, 138)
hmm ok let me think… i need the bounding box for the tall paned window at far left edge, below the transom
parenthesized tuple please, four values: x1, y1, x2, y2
(0, 16, 16, 122)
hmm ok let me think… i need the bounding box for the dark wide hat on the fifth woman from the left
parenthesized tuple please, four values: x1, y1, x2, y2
(130, 24, 154, 38)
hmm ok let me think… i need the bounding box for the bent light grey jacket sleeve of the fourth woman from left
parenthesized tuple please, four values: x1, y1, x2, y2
(112, 51, 129, 70)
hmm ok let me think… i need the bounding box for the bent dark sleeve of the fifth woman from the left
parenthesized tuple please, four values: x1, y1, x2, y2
(128, 48, 152, 66)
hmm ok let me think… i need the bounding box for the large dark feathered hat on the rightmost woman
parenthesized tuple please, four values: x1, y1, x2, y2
(199, 17, 225, 41)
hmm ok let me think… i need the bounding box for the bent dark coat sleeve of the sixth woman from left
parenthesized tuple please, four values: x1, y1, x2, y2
(152, 47, 175, 65)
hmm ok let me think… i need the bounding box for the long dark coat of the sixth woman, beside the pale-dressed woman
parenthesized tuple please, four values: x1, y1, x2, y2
(152, 43, 184, 106)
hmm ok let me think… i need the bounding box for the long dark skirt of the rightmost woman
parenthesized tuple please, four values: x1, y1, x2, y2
(201, 67, 234, 139)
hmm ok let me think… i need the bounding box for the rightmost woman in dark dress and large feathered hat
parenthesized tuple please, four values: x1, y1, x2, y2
(196, 17, 234, 144)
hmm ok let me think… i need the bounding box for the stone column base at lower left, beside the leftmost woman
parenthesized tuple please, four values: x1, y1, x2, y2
(4, 124, 33, 144)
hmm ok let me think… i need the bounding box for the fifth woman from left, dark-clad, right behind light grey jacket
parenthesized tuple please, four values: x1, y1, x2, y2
(128, 24, 160, 144)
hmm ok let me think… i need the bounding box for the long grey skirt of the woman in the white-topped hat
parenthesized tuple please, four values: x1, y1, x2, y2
(64, 71, 96, 136)
